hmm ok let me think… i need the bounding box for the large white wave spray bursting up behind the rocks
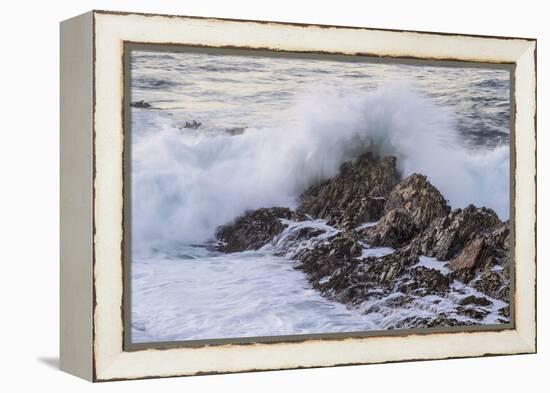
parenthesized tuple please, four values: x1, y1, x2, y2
(132, 84, 509, 251)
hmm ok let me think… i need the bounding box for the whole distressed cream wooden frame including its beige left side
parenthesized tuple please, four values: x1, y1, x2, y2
(60, 11, 536, 381)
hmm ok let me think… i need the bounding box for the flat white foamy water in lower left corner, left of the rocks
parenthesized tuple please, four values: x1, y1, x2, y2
(132, 250, 382, 343)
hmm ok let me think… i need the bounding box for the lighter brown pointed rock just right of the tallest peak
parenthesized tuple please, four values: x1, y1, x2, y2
(365, 173, 450, 247)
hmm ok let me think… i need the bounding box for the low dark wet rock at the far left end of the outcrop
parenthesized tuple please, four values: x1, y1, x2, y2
(216, 207, 304, 252)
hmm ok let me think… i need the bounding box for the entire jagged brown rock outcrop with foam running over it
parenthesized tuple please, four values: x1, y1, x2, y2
(216, 153, 511, 329)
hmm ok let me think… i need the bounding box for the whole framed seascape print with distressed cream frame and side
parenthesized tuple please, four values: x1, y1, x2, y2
(61, 11, 536, 381)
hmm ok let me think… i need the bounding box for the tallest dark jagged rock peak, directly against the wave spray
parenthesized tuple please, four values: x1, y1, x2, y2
(298, 153, 399, 229)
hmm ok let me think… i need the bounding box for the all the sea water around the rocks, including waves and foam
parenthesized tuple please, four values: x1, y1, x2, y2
(131, 51, 510, 342)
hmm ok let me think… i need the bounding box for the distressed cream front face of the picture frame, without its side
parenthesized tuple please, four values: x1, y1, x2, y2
(61, 11, 536, 381)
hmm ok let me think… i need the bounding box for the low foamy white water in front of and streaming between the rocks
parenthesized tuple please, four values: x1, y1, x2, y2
(131, 216, 506, 342)
